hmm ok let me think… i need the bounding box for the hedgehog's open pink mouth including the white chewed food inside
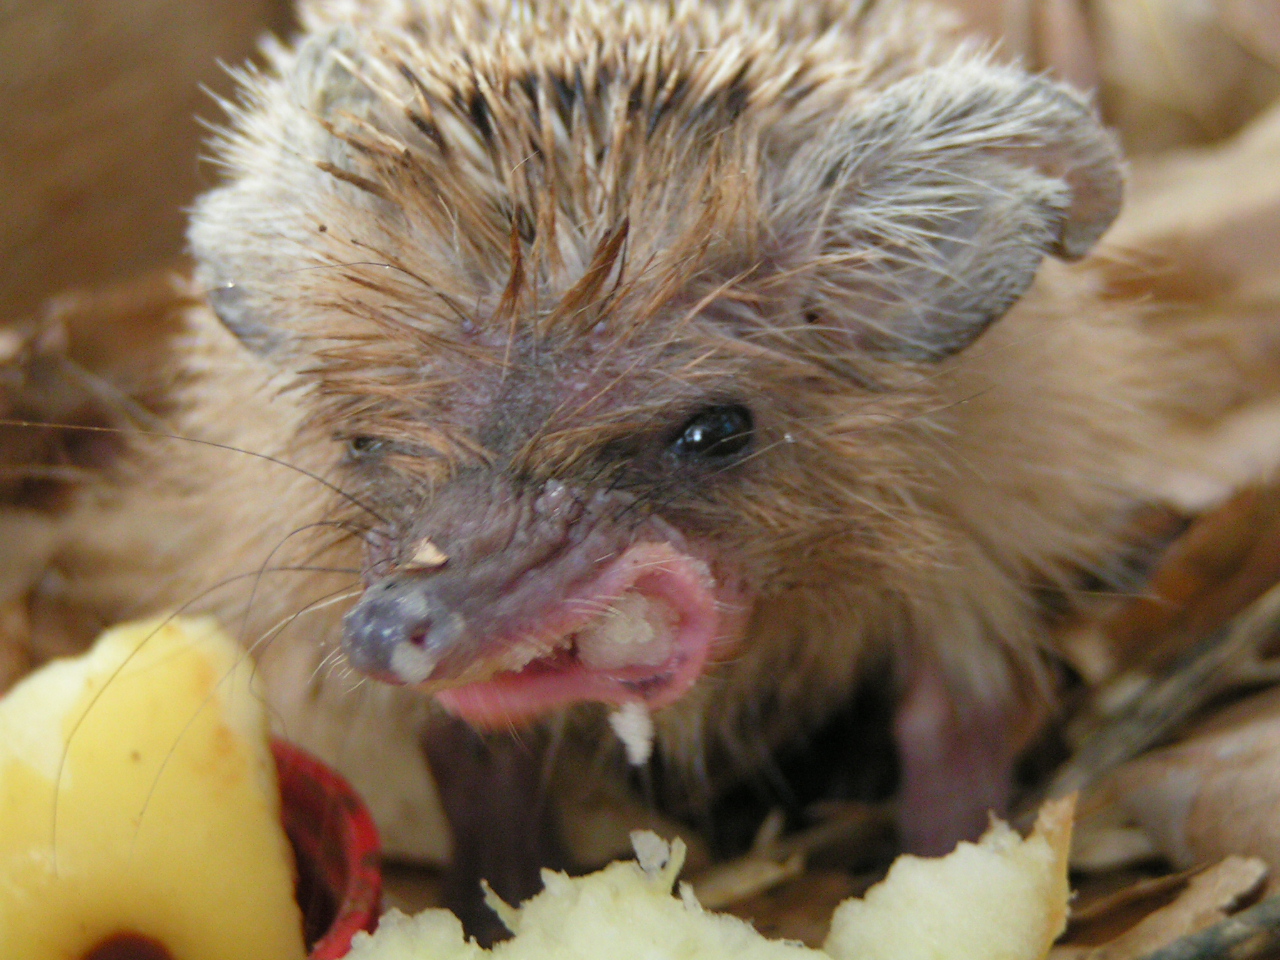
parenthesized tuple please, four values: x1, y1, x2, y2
(435, 543, 735, 727)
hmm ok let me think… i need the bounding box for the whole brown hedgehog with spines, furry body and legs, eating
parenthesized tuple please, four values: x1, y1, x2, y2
(24, 0, 1213, 931)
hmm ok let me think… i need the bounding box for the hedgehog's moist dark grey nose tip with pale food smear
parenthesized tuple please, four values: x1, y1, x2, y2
(342, 573, 463, 684)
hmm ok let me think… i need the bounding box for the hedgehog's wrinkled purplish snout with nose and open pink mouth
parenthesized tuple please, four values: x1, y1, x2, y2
(343, 481, 748, 727)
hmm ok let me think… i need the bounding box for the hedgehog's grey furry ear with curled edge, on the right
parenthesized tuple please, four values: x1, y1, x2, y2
(774, 61, 1123, 360)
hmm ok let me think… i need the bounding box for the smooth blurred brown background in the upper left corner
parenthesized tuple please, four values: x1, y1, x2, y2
(0, 0, 292, 319)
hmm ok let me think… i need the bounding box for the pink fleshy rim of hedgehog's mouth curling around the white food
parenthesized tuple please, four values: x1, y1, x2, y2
(436, 543, 722, 727)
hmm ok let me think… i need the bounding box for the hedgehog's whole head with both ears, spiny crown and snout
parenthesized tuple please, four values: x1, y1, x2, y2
(191, 3, 1119, 723)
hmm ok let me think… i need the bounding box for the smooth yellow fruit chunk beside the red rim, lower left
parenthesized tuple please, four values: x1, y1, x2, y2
(0, 620, 306, 960)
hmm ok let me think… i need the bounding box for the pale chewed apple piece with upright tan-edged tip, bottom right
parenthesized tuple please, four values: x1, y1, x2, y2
(824, 799, 1075, 960)
